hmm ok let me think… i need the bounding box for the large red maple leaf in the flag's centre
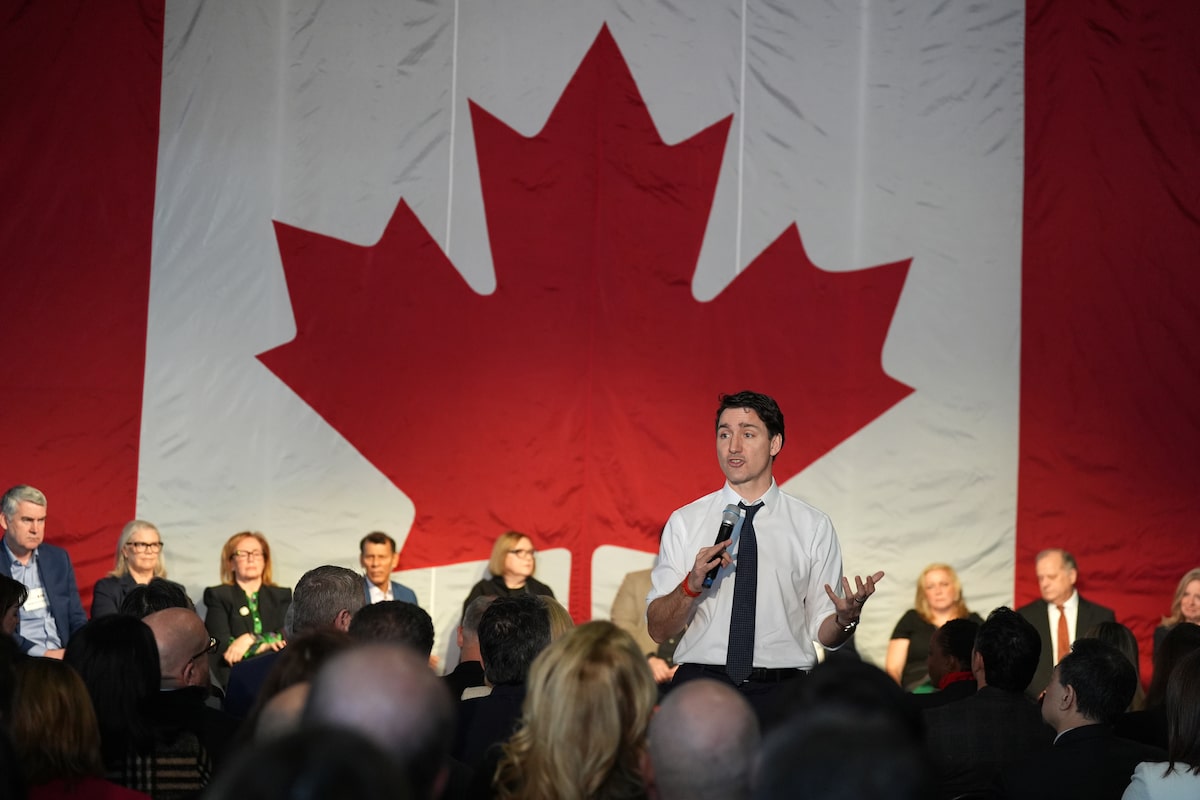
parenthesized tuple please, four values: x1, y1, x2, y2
(259, 23, 911, 616)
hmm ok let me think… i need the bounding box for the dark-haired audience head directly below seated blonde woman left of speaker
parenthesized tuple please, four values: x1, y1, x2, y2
(479, 595, 550, 686)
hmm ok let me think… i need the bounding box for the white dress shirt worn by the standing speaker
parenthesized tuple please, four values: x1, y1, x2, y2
(646, 481, 842, 669)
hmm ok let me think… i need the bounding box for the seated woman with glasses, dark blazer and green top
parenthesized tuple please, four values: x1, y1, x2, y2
(204, 530, 292, 686)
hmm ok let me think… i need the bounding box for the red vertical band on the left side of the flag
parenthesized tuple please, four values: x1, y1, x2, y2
(0, 0, 163, 607)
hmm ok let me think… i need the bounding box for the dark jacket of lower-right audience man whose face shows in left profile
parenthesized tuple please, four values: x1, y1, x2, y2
(1003, 724, 1166, 800)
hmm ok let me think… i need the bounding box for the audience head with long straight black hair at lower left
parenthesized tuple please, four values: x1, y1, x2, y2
(64, 614, 162, 762)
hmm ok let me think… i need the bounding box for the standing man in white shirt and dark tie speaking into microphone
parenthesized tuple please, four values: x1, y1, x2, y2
(646, 392, 883, 718)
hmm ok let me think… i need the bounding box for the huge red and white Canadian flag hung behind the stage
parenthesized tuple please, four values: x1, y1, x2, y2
(0, 0, 1200, 676)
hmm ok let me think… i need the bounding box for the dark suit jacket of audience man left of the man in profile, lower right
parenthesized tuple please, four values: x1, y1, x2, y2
(922, 686, 1054, 798)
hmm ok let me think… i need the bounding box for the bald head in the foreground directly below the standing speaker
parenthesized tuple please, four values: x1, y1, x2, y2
(643, 679, 761, 800)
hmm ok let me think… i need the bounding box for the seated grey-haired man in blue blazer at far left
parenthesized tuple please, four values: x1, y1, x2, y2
(0, 486, 88, 658)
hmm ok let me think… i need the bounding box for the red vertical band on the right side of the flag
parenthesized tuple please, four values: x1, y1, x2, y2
(1016, 0, 1200, 678)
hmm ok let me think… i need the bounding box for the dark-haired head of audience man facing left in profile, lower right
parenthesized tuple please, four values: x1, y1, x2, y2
(1042, 639, 1138, 733)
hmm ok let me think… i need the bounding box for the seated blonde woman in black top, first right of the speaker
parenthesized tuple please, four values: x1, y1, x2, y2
(883, 564, 983, 692)
